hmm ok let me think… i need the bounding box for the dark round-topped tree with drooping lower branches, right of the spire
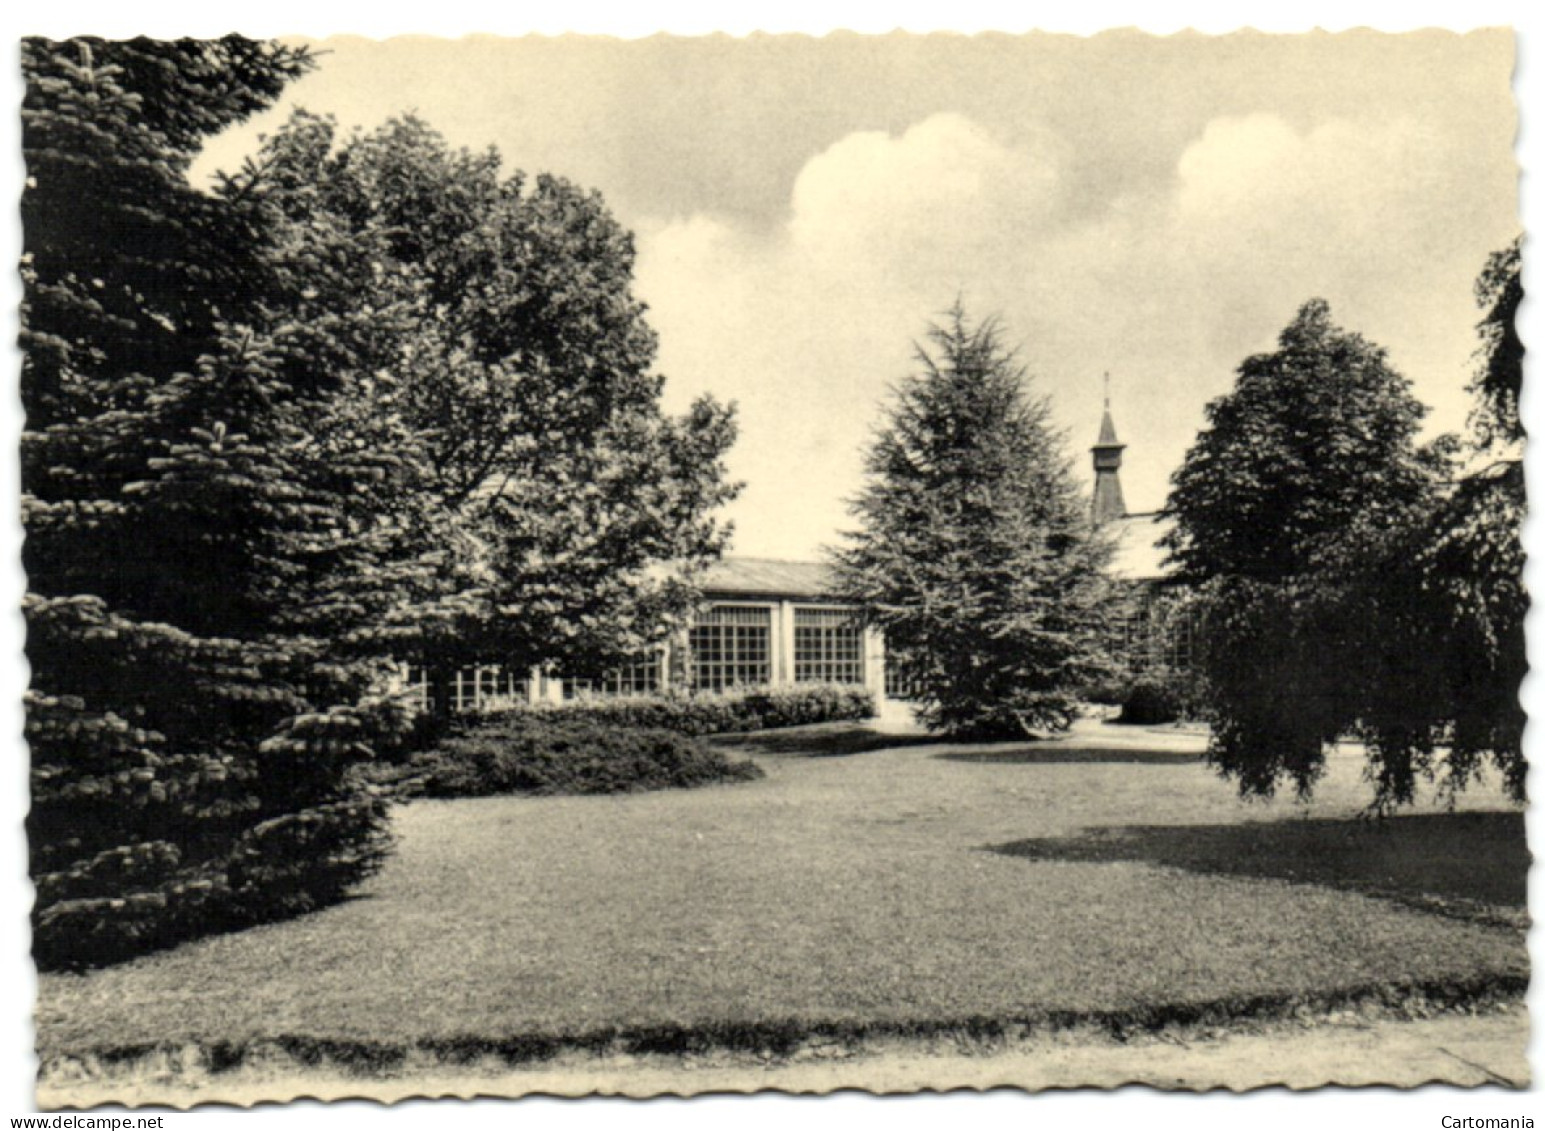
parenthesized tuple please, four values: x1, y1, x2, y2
(1168, 300, 1522, 810)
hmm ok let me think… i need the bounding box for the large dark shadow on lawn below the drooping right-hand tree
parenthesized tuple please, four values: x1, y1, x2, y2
(990, 811, 1530, 927)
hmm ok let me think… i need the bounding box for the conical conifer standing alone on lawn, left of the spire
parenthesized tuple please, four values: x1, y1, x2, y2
(836, 306, 1109, 737)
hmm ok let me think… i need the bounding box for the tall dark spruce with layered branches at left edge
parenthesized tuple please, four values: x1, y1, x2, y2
(22, 37, 389, 967)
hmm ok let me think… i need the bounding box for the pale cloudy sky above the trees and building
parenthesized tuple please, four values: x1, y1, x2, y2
(195, 29, 1519, 558)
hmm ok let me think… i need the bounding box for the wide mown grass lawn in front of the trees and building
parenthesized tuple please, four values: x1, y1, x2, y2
(37, 723, 1528, 1063)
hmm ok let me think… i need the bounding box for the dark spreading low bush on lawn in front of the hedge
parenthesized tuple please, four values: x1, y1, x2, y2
(411, 712, 762, 797)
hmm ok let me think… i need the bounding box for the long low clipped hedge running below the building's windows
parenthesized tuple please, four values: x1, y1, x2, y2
(511, 683, 874, 735)
